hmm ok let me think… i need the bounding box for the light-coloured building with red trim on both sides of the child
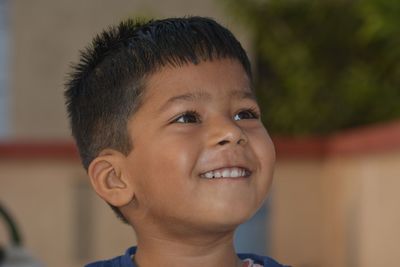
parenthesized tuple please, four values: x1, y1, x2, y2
(0, 0, 400, 267)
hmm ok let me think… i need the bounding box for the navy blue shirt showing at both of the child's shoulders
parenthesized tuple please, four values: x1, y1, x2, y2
(85, 247, 288, 267)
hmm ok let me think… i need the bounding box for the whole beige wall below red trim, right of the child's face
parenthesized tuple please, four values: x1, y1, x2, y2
(270, 147, 400, 267)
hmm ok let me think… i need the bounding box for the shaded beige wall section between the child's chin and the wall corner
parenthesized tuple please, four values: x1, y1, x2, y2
(268, 159, 323, 267)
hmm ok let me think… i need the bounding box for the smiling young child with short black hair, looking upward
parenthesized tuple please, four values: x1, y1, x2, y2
(65, 17, 288, 267)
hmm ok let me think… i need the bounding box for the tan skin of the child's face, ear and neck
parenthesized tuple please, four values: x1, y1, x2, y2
(89, 59, 275, 267)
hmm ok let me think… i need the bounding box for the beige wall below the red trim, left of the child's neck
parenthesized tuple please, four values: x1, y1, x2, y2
(0, 159, 135, 267)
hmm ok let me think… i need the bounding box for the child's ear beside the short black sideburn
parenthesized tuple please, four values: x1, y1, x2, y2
(88, 149, 135, 207)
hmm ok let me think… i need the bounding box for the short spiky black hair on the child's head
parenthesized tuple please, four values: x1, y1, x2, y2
(65, 17, 251, 222)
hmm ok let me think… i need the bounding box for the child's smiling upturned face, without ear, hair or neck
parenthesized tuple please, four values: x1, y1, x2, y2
(126, 59, 275, 231)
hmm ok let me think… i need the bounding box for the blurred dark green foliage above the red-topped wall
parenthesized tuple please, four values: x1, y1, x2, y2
(224, 0, 400, 135)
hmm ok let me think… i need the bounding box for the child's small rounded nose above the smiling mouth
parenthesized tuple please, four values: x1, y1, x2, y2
(210, 116, 248, 146)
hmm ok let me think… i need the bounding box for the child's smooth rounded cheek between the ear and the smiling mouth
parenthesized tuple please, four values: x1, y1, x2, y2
(134, 135, 202, 206)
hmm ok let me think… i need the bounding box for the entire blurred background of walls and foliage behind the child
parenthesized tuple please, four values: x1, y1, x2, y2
(0, 0, 400, 267)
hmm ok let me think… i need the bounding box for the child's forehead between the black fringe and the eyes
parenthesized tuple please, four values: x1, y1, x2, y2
(143, 59, 254, 104)
